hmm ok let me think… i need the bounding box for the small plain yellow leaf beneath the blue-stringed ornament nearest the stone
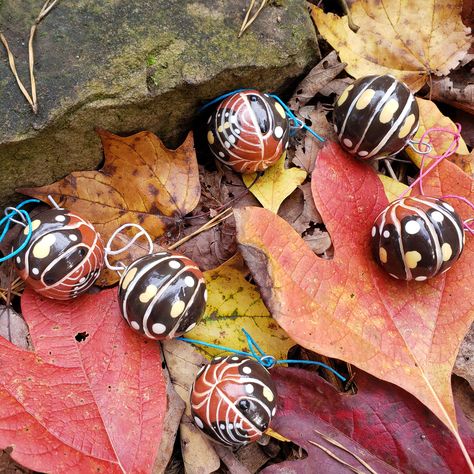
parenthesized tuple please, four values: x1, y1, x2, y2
(243, 153, 307, 212)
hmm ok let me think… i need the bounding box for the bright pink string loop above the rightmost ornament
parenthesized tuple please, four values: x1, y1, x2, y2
(399, 123, 474, 235)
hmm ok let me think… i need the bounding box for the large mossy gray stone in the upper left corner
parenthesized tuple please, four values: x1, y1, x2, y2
(0, 0, 319, 205)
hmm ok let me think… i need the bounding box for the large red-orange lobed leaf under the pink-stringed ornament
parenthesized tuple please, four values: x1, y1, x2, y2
(235, 143, 474, 458)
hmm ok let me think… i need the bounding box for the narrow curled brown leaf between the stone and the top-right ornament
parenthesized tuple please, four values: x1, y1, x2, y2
(288, 51, 346, 112)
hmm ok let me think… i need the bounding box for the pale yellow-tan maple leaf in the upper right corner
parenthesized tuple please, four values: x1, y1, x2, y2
(312, 0, 470, 91)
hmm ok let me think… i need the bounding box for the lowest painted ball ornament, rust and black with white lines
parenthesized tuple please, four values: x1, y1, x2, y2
(191, 356, 277, 447)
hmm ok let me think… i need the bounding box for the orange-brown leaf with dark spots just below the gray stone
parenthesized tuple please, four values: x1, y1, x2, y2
(18, 130, 201, 285)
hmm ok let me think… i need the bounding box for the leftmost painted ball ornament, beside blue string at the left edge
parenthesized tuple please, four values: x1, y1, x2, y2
(15, 209, 104, 300)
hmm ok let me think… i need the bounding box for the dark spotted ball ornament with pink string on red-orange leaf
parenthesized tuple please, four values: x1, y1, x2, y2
(372, 196, 465, 281)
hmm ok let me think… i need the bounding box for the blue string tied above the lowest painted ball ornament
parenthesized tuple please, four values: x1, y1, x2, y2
(176, 328, 347, 382)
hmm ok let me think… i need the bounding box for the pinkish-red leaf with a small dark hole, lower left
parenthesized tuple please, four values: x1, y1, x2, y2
(0, 289, 166, 474)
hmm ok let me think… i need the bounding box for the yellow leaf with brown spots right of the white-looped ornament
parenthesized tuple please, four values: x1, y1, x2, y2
(185, 254, 294, 359)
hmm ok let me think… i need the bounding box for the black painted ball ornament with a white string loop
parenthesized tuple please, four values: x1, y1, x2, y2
(119, 251, 207, 339)
